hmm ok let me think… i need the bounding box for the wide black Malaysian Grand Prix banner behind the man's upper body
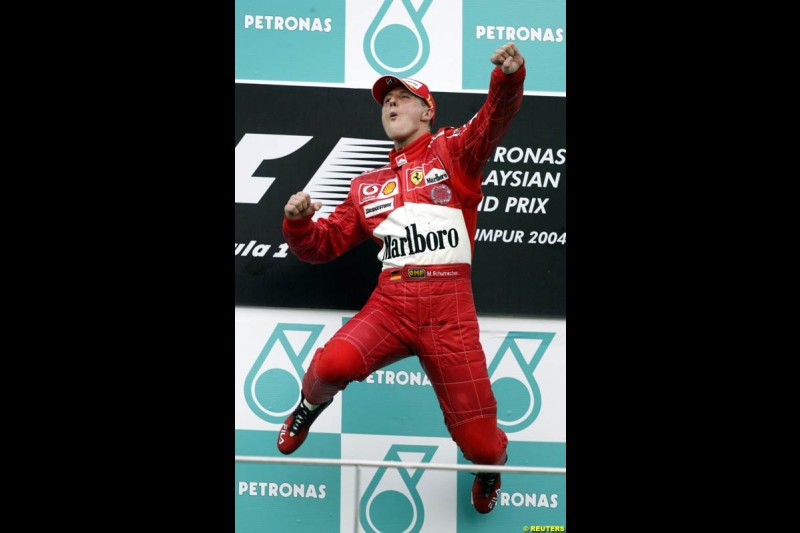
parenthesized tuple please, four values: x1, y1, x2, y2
(235, 81, 567, 318)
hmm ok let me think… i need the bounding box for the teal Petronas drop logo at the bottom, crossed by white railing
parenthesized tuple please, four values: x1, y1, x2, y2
(359, 444, 438, 533)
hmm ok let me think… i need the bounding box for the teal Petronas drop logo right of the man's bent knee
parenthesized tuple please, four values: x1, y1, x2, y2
(488, 331, 556, 433)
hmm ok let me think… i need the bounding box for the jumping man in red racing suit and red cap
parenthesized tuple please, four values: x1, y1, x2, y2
(278, 43, 525, 513)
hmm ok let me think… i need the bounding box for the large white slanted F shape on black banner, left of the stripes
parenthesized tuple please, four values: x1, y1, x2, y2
(235, 133, 311, 204)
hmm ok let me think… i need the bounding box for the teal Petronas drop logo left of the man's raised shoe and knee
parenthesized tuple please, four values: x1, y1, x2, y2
(244, 323, 324, 424)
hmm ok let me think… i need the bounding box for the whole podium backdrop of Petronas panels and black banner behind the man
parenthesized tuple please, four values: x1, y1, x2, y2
(234, 0, 564, 533)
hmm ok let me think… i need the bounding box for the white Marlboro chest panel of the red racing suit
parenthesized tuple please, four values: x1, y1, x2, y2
(372, 202, 472, 270)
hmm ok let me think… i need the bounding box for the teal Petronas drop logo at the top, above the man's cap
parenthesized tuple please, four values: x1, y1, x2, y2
(364, 0, 433, 78)
